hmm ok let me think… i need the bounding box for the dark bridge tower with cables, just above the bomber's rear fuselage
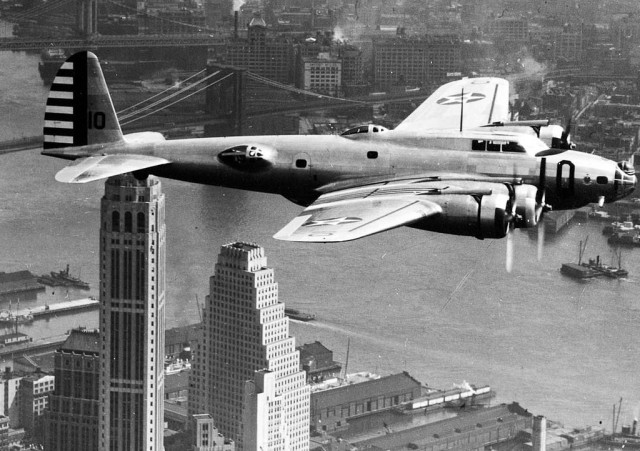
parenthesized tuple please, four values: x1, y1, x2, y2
(204, 63, 245, 136)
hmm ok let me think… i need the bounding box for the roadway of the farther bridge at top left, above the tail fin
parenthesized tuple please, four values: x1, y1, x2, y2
(0, 32, 231, 51)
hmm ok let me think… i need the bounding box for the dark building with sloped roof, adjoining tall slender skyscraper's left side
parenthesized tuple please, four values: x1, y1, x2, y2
(45, 329, 101, 451)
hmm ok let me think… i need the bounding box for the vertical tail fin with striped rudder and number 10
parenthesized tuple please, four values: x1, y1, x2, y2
(43, 51, 123, 151)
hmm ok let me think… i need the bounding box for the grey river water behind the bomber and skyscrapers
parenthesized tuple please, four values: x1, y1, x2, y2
(0, 47, 640, 427)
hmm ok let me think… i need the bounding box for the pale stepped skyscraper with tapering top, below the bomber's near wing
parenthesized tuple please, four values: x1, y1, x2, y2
(189, 242, 309, 451)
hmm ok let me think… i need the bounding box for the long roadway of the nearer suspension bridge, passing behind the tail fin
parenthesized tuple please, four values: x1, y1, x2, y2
(0, 91, 428, 155)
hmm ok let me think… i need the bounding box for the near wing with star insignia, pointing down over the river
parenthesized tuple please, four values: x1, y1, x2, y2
(274, 188, 442, 243)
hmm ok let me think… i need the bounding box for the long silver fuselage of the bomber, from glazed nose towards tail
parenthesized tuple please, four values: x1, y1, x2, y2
(68, 131, 633, 210)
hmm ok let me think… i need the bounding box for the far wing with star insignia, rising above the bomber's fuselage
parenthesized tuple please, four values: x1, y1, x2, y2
(395, 77, 510, 132)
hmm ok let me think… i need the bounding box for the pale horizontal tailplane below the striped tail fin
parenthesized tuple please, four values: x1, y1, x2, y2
(56, 154, 171, 183)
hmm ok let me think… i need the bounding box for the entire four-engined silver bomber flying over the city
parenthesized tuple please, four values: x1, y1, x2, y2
(42, 51, 636, 264)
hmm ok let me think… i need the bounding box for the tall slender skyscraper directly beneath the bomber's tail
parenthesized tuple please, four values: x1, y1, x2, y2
(99, 175, 165, 451)
